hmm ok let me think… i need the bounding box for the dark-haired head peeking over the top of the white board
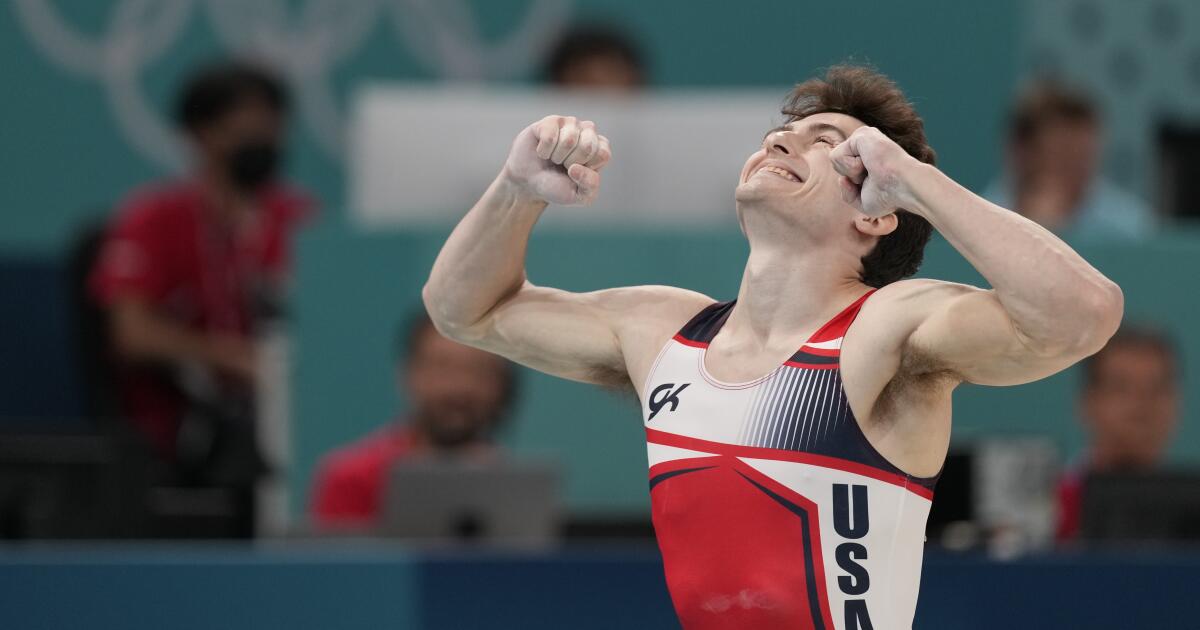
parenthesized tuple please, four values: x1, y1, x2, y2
(545, 25, 646, 91)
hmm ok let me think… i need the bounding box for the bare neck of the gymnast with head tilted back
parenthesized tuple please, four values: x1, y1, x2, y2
(725, 237, 869, 347)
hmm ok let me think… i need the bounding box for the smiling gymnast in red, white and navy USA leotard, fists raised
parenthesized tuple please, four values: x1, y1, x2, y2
(424, 66, 1123, 630)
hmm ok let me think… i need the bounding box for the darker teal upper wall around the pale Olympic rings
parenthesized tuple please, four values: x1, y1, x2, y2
(0, 0, 1019, 253)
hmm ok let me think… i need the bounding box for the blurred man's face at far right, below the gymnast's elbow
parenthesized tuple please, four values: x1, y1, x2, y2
(1082, 344, 1180, 468)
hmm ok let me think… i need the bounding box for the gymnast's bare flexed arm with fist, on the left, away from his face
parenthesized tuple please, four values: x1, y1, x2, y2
(422, 116, 703, 385)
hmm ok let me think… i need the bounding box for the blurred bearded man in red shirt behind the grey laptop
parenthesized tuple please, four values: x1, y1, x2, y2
(312, 310, 516, 529)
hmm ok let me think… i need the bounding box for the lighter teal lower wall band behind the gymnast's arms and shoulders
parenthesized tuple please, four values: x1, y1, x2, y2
(293, 230, 1200, 512)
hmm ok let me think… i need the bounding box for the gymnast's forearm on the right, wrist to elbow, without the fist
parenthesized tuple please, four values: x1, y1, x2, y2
(907, 163, 1122, 350)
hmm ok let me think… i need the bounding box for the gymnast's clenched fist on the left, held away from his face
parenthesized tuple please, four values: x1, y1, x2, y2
(502, 116, 612, 205)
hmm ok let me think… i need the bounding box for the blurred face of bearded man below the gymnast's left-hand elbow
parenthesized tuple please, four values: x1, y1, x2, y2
(403, 328, 505, 449)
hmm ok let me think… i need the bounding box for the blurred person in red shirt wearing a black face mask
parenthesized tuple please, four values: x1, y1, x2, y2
(90, 62, 311, 506)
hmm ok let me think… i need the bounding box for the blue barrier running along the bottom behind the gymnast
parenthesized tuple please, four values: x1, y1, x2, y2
(0, 542, 1200, 630)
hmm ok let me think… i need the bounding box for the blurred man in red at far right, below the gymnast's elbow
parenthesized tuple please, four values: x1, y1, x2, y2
(1057, 326, 1180, 541)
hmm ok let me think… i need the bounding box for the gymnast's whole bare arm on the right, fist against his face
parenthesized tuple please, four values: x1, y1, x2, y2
(830, 127, 1123, 385)
